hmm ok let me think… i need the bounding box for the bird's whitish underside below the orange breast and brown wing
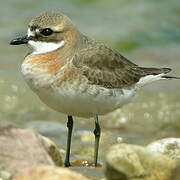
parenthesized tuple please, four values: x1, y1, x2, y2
(22, 63, 135, 117)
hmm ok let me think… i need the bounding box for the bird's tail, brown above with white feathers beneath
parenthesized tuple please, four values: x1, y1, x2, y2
(136, 67, 180, 89)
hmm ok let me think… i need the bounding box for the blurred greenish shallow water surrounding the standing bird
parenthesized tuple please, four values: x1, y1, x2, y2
(0, 0, 180, 178)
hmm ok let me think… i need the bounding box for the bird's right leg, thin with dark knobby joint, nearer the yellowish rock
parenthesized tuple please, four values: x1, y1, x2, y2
(94, 114, 101, 166)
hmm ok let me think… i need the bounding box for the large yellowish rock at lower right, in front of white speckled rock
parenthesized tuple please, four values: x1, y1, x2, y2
(105, 144, 176, 180)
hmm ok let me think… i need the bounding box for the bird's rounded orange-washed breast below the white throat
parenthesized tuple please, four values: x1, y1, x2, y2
(21, 53, 60, 90)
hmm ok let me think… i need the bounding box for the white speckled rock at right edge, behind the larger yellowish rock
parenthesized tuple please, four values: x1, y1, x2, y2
(147, 138, 180, 164)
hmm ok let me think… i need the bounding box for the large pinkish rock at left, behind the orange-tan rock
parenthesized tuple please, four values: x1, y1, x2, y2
(0, 126, 62, 176)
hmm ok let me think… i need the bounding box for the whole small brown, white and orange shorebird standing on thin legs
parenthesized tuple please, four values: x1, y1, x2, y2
(10, 12, 178, 167)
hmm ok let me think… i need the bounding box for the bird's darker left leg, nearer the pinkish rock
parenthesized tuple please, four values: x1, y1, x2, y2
(64, 116, 73, 167)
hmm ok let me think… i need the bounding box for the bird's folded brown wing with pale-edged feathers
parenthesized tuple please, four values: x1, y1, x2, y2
(72, 45, 170, 88)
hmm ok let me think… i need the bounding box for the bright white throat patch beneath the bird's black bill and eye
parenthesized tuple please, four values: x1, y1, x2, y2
(28, 40, 65, 54)
